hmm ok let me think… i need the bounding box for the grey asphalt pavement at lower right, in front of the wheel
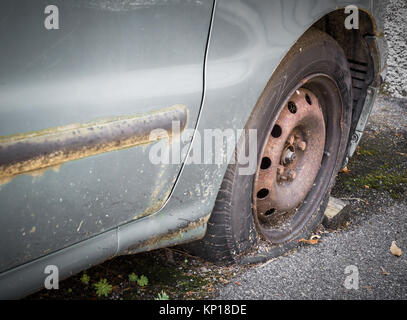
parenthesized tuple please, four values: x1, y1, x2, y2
(217, 203, 407, 300)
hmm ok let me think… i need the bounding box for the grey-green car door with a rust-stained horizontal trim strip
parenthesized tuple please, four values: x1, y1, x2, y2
(0, 0, 213, 272)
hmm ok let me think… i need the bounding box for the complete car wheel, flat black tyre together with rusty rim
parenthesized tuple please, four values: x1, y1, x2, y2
(192, 29, 352, 262)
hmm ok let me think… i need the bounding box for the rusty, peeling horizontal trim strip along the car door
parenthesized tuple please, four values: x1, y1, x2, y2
(0, 105, 187, 184)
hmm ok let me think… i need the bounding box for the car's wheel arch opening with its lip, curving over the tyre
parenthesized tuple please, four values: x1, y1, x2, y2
(252, 4, 387, 166)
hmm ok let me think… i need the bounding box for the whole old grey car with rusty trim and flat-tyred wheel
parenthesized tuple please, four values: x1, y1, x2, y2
(0, 0, 386, 298)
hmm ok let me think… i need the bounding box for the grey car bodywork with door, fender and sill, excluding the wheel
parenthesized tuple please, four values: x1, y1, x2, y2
(0, 0, 386, 298)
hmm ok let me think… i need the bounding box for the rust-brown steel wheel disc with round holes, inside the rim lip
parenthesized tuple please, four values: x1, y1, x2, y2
(253, 88, 326, 242)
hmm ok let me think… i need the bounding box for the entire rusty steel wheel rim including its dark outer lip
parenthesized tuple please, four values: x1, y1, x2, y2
(253, 74, 342, 244)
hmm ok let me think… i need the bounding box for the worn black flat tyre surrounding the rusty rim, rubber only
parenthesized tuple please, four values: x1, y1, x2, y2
(191, 29, 352, 263)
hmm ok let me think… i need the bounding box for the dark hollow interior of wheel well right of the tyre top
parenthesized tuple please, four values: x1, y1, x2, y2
(312, 9, 382, 136)
